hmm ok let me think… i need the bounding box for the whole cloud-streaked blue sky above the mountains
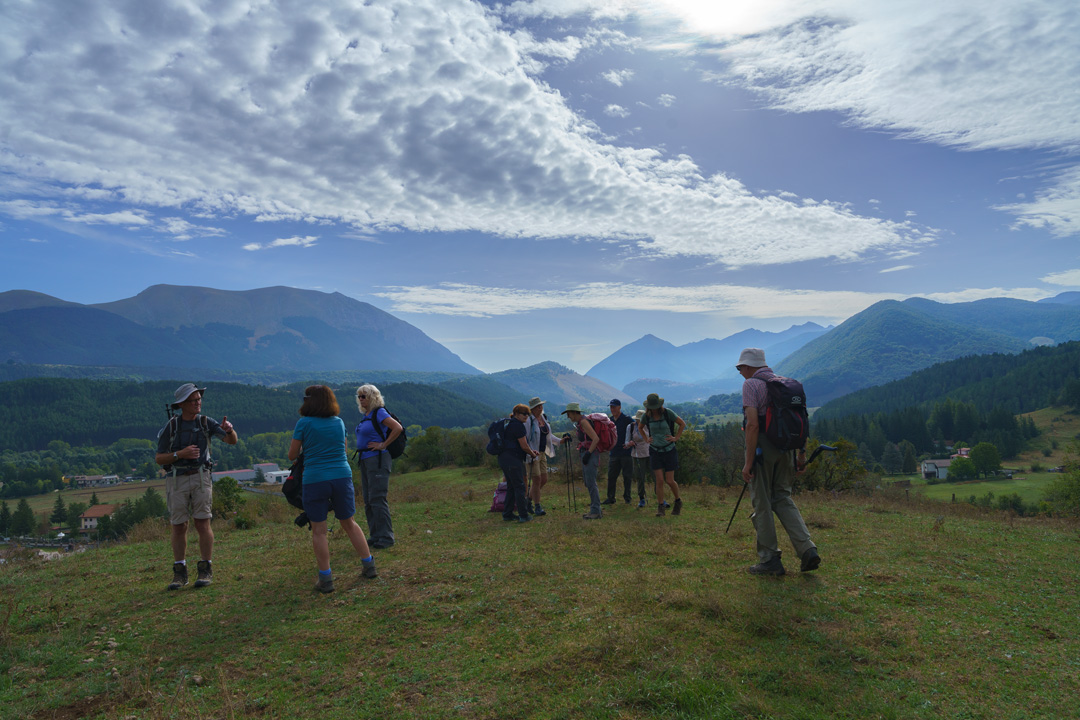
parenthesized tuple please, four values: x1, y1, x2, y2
(0, 0, 1080, 372)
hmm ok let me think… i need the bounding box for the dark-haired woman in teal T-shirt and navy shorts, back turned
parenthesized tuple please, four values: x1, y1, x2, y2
(288, 385, 378, 593)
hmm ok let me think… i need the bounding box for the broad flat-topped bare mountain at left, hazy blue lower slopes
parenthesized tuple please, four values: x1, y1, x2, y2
(0, 285, 480, 375)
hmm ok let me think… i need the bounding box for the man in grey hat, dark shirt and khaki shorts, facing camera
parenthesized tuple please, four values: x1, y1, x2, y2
(153, 382, 239, 590)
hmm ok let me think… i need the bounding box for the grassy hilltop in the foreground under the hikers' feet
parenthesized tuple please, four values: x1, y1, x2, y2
(0, 471, 1080, 720)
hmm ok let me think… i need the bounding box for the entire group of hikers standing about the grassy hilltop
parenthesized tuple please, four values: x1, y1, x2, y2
(154, 348, 821, 593)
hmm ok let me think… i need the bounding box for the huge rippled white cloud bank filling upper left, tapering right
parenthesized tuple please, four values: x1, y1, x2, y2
(0, 0, 933, 266)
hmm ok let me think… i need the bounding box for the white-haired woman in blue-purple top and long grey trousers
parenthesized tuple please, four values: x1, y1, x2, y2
(356, 385, 402, 549)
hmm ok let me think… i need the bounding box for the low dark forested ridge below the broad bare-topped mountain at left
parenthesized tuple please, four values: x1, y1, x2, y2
(0, 378, 507, 452)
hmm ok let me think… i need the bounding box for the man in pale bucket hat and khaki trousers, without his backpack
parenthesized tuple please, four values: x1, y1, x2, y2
(735, 348, 821, 575)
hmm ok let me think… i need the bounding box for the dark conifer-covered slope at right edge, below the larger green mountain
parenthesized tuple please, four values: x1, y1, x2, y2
(814, 342, 1080, 421)
